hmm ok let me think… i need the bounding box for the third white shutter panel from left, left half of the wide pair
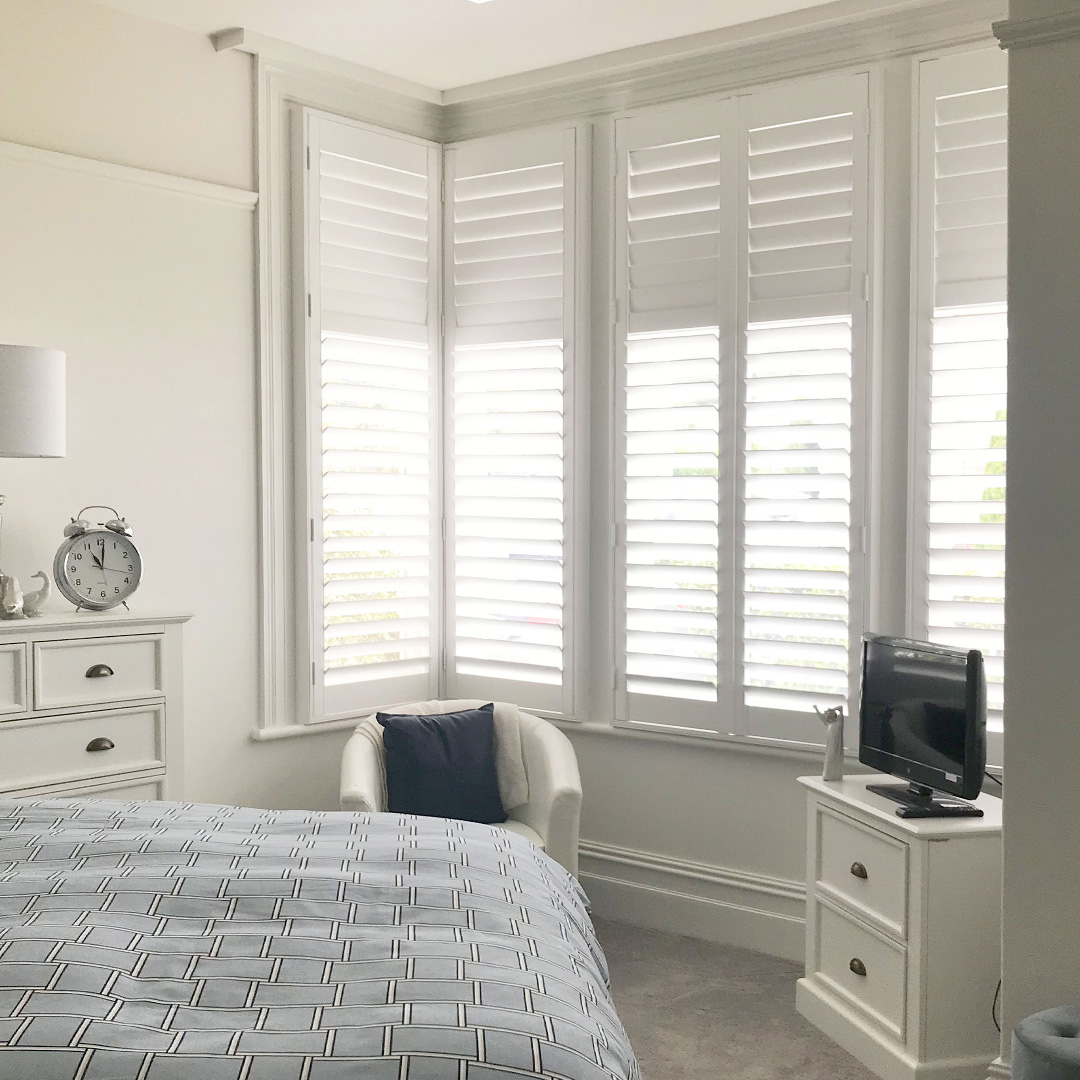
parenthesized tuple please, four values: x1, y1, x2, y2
(617, 106, 730, 731)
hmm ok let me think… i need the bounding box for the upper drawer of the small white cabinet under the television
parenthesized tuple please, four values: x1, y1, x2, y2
(818, 809, 908, 939)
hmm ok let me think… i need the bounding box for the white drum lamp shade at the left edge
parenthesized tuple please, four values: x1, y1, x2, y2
(0, 345, 67, 458)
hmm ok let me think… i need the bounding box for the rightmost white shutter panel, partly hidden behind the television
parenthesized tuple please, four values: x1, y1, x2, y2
(913, 49, 1008, 761)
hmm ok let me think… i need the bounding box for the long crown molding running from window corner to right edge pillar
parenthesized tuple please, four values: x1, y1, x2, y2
(441, 0, 1005, 141)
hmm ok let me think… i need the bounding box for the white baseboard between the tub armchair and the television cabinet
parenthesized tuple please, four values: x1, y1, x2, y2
(578, 840, 806, 961)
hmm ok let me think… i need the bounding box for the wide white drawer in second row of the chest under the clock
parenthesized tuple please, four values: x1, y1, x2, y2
(0, 705, 165, 791)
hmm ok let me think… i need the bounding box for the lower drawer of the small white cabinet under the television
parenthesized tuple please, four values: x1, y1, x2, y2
(814, 901, 907, 1041)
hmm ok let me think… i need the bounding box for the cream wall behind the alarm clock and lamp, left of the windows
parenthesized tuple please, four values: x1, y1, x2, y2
(0, 0, 345, 807)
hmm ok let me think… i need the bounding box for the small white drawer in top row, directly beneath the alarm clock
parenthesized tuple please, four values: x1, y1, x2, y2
(33, 634, 162, 710)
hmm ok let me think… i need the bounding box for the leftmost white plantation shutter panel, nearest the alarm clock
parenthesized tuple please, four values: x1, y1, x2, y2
(305, 112, 437, 718)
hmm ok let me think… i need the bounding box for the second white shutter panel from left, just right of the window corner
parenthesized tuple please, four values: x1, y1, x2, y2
(446, 129, 576, 713)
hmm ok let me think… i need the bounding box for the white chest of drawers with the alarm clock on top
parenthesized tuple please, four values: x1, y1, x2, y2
(0, 612, 188, 799)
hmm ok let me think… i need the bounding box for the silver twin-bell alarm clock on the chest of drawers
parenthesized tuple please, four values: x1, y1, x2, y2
(53, 507, 143, 611)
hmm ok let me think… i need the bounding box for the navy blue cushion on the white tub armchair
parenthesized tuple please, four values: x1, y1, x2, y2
(375, 704, 507, 825)
